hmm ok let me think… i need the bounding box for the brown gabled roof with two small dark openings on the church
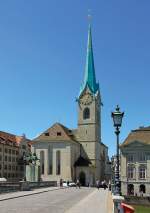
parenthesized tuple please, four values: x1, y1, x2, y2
(33, 123, 78, 143)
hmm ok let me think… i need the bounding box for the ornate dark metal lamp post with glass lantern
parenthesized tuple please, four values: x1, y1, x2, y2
(111, 105, 124, 195)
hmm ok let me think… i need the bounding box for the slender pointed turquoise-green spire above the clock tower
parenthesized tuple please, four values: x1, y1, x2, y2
(79, 24, 99, 96)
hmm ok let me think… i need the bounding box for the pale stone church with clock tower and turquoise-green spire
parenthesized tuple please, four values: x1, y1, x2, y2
(32, 25, 110, 185)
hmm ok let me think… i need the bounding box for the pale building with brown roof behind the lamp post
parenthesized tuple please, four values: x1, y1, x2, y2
(120, 127, 150, 196)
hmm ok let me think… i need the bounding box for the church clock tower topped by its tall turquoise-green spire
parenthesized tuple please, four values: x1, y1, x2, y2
(77, 25, 101, 179)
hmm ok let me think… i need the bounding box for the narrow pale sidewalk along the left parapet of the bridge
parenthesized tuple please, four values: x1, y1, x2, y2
(0, 187, 63, 201)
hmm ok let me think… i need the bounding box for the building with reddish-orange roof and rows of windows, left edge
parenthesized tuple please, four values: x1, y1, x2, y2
(0, 131, 30, 181)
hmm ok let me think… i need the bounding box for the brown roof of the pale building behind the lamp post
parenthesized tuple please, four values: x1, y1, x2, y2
(120, 126, 150, 147)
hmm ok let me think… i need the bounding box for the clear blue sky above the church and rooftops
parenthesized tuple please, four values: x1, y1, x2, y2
(0, 0, 150, 156)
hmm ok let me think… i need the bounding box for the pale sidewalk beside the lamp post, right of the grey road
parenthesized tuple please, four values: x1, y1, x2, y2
(65, 189, 112, 213)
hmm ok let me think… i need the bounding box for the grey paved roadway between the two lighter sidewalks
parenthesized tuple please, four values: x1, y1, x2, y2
(0, 188, 95, 213)
